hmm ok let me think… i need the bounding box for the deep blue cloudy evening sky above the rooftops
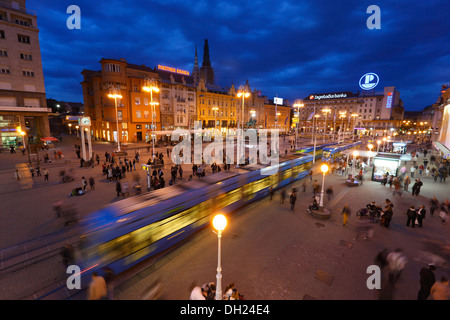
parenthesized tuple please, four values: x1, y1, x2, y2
(31, 0, 450, 111)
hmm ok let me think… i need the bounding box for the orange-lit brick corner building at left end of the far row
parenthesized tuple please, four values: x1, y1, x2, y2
(81, 59, 161, 143)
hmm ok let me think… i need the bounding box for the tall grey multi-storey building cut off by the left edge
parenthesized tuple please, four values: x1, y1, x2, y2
(0, 0, 51, 147)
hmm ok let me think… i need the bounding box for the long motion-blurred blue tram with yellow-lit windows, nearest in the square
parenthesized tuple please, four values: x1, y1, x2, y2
(76, 155, 312, 286)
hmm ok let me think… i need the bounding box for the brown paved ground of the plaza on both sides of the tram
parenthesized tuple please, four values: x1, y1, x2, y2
(0, 136, 450, 300)
